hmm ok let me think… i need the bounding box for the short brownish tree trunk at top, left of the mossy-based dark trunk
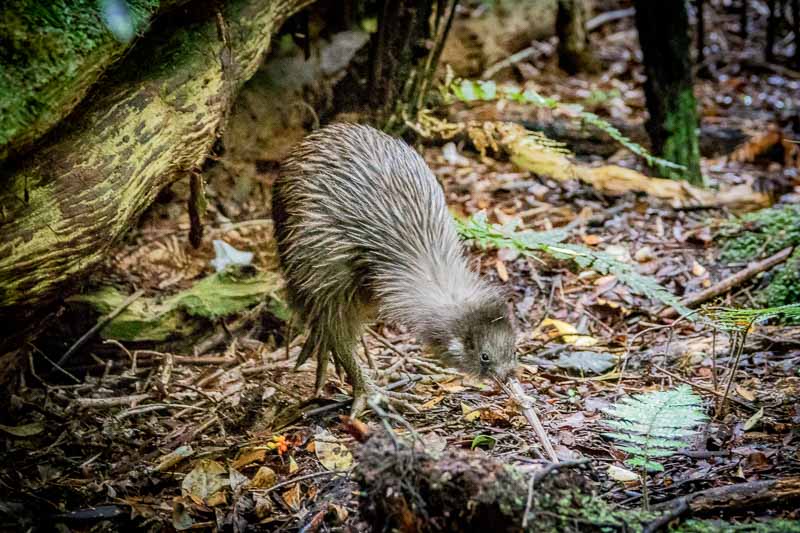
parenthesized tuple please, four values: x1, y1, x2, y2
(556, 0, 600, 74)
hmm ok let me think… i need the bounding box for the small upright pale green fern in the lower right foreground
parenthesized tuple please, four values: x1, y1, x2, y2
(604, 385, 706, 510)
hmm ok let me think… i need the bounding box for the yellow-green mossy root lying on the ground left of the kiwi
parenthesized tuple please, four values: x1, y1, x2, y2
(68, 267, 288, 341)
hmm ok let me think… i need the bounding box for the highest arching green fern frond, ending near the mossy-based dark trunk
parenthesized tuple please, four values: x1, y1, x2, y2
(442, 80, 686, 170)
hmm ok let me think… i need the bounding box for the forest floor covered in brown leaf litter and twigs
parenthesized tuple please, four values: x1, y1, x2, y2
(0, 3, 800, 531)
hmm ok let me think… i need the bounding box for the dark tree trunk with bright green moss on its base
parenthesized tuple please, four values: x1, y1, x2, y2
(634, 0, 704, 185)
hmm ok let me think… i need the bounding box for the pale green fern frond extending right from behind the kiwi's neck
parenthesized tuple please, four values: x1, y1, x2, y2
(456, 213, 691, 316)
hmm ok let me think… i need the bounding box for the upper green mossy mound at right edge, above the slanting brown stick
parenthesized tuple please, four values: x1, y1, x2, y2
(720, 205, 800, 262)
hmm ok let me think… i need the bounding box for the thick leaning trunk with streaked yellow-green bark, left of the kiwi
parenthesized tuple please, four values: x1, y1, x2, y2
(0, 0, 313, 320)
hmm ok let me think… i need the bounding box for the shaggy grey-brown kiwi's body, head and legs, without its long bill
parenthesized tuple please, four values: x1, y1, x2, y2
(272, 123, 517, 416)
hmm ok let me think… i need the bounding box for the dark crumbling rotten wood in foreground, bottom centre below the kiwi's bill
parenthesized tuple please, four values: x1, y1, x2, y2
(355, 434, 592, 532)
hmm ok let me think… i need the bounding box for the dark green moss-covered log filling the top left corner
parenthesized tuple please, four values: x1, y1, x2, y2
(0, 0, 162, 160)
